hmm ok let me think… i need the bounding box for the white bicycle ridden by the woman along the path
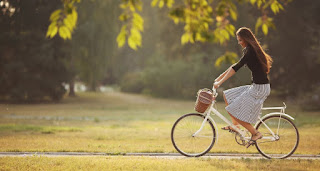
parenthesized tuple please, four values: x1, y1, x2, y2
(171, 89, 299, 159)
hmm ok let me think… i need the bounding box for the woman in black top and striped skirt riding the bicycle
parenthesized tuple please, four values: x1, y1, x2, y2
(213, 27, 272, 148)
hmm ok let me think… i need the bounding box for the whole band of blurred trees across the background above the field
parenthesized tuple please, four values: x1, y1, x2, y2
(0, 0, 320, 109)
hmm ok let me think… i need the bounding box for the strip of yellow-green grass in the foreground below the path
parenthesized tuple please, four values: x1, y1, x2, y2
(0, 156, 320, 171)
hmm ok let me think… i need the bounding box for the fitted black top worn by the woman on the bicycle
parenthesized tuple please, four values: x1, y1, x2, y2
(232, 45, 269, 84)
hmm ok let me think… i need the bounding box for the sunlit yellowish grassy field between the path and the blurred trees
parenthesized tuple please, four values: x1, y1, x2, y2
(0, 92, 320, 155)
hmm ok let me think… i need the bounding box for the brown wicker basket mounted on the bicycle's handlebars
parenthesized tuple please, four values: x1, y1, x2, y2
(194, 88, 213, 113)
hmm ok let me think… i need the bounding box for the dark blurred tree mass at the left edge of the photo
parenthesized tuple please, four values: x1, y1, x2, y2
(0, 1, 69, 101)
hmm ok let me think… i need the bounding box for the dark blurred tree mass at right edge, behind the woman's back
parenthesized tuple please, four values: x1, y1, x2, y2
(266, 0, 320, 110)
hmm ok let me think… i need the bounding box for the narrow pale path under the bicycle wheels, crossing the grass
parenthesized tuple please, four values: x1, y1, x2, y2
(0, 152, 320, 160)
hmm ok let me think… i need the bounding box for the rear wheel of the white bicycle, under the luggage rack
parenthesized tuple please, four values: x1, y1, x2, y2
(256, 115, 299, 159)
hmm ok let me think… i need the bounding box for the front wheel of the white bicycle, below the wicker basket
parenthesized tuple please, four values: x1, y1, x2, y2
(171, 113, 216, 157)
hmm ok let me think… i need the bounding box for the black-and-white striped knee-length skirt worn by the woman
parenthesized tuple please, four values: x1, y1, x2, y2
(223, 83, 270, 124)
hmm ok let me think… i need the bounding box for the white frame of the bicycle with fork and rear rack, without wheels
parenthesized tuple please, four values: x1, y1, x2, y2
(192, 89, 294, 141)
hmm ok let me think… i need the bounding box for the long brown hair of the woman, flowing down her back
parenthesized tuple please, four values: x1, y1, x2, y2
(236, 27, 273, 73)
